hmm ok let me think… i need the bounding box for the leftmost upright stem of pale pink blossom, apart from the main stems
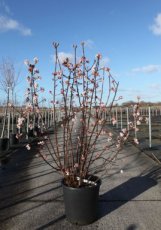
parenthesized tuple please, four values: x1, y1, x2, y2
(12, 57, 46, 141)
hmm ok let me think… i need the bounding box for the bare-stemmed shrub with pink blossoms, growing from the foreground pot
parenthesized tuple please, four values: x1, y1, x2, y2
(33, 43, 128, 187)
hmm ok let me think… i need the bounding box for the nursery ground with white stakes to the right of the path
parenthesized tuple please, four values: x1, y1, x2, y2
(108, 107, 161, 163)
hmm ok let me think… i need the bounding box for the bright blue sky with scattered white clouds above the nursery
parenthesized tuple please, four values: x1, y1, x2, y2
(0, 0, 161, 105)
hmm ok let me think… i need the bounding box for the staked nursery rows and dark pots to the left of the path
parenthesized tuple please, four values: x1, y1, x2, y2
(0, 109, 59, 162)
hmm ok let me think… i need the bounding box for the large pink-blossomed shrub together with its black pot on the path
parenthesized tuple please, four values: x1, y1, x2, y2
(19, 42, 139, 225)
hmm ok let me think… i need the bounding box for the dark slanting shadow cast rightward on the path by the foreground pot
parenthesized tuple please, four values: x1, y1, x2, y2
(99, 172, 157, 220)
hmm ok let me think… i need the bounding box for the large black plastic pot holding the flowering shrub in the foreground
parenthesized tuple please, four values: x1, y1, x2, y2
(62, 176, 101, 225)
